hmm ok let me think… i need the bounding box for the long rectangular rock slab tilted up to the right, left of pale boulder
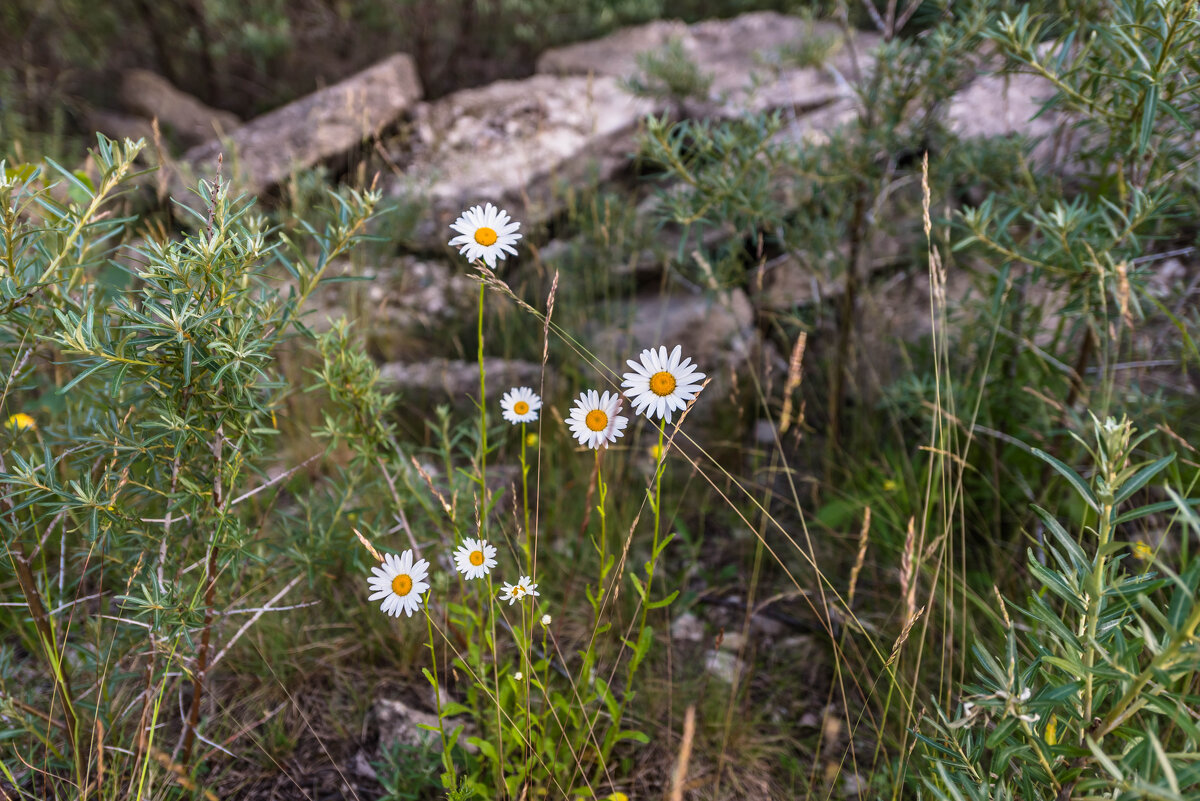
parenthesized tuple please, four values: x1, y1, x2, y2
(176, 53, 422, 199)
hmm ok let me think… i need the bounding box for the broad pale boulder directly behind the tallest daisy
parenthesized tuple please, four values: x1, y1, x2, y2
(392, 76, 659, 247)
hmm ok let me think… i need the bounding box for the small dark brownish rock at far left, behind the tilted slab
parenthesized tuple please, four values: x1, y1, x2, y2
(120, 70, 241, 146)
